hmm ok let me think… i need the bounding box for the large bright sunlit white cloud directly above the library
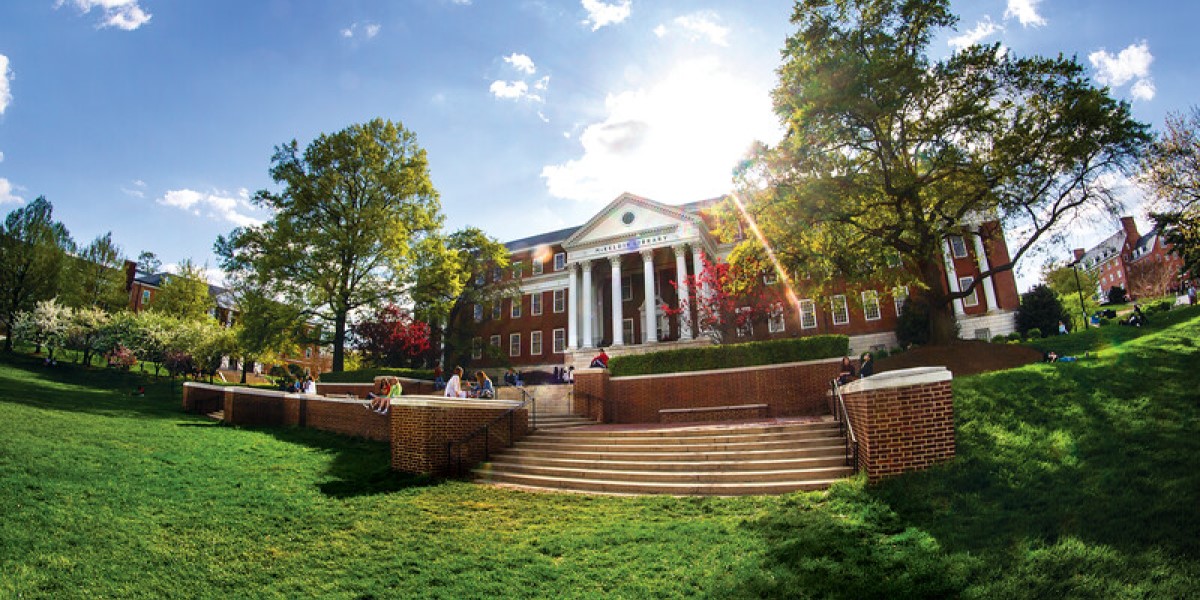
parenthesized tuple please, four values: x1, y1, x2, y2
(541, 58, 781, 204)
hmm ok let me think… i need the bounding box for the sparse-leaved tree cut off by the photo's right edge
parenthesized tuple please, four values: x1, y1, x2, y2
(1141, 107, 1200, 274)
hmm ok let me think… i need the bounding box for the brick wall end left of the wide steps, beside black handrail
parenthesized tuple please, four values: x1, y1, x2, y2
(391, 397, 529, 475)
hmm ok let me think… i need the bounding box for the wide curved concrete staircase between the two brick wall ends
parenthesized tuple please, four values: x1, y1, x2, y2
(473, 420, 852, 496)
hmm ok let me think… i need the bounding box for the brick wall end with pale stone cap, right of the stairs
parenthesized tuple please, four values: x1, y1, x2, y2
(841, 367, 955, 482)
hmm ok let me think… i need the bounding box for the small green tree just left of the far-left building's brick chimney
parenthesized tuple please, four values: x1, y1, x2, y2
(62, 232, 130, 312)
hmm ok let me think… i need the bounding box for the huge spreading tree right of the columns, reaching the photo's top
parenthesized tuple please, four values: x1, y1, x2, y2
(738, 0, 1148, 343)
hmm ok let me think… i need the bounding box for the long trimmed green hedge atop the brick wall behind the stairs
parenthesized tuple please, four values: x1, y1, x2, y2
(608, 335, 850, 377)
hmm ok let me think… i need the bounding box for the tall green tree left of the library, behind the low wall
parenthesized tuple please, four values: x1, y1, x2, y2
(216, 119, 443, 371)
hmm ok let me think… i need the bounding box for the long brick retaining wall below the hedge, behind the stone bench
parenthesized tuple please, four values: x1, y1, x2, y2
(574, 359, 841, 424)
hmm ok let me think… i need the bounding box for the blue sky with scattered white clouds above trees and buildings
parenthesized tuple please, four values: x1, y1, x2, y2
(0, 0, 1200, 289)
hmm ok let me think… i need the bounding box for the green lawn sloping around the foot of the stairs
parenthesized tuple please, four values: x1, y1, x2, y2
(0, 310, 1200, 599)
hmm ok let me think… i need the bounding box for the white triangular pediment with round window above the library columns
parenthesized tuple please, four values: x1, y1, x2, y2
(563, 193, 704, 251)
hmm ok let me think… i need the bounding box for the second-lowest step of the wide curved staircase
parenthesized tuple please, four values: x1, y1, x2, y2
(491, 449, 846, 474)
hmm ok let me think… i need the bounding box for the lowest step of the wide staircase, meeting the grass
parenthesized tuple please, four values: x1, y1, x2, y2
(479, 468, 850, 496)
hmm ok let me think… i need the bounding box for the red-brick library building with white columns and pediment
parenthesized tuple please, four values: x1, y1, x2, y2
(452, 193, 1020, 370)
